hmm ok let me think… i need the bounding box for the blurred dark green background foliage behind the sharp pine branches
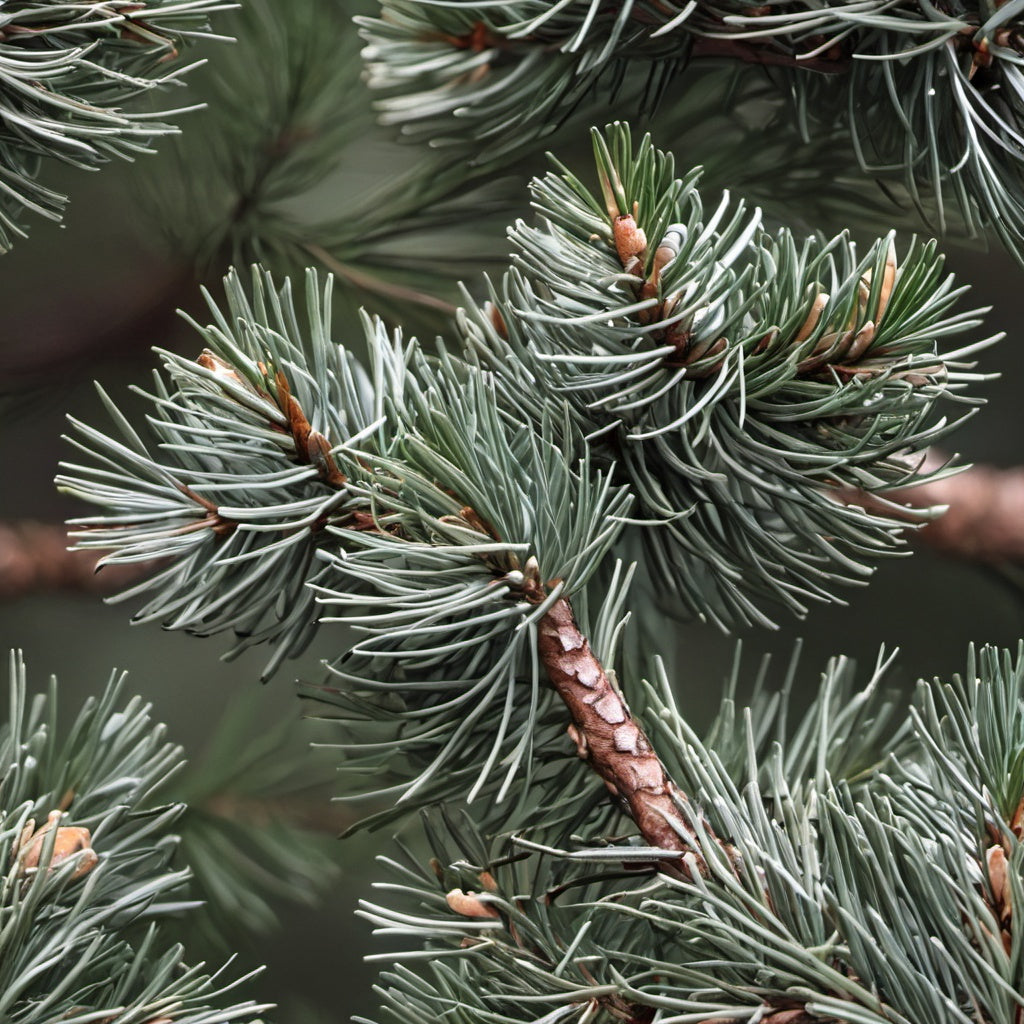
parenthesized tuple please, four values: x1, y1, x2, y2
(0, 0, 1024, 1022)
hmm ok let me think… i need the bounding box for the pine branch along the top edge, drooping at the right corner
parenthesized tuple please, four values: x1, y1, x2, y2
(360, 0, 1024, 268)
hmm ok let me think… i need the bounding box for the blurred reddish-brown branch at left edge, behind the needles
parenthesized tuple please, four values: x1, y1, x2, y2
(0, 520, 153, 601)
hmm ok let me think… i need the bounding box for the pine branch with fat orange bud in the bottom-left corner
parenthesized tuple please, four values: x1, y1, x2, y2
(0, 653, 267, 1024)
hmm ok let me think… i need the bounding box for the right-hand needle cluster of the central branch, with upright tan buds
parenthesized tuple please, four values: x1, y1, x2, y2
(468, 126, 987, 626)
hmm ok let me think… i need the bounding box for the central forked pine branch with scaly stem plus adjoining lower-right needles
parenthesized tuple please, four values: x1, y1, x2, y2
(51, 116, 1024, 1024)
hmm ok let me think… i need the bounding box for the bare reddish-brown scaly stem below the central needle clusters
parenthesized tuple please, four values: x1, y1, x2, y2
(538, 598, 705, 870)
